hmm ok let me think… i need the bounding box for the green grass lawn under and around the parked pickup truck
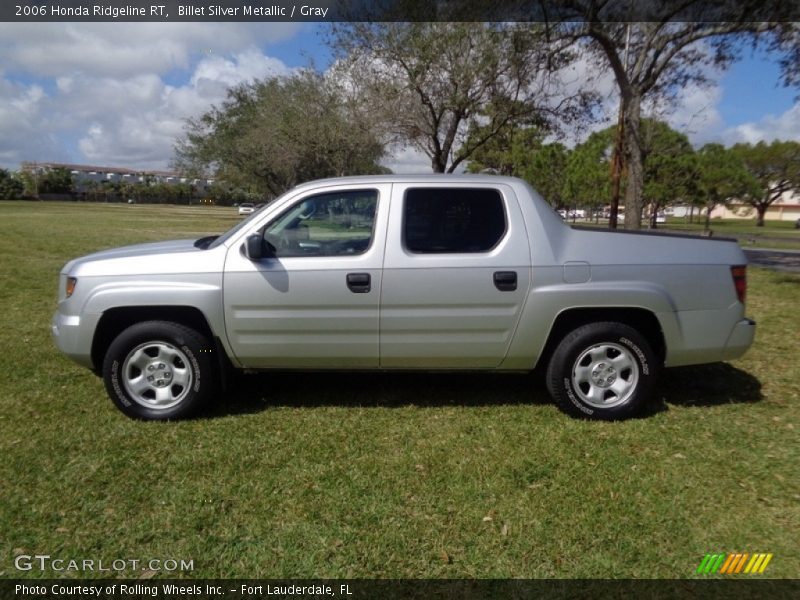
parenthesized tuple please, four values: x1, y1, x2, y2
(0, 202, 800, 578)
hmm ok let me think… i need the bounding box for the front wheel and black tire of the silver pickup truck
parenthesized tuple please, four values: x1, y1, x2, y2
(103, 321, 216, 421)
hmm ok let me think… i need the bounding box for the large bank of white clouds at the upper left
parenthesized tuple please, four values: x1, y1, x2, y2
(0, 23, 297, 168)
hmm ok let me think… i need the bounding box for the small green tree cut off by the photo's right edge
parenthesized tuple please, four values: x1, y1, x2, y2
(733, 140, 800, 227)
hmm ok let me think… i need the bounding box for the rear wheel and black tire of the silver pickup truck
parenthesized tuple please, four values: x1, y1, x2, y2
(545, 322, 659, 421)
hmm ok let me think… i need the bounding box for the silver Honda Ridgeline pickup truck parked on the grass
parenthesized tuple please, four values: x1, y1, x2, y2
(52, 175, 755, 419)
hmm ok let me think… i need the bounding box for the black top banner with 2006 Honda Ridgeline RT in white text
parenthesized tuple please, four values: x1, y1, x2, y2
(0, 0, 800, 22)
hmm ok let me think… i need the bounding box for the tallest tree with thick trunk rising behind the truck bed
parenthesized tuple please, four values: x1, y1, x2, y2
(555, 0, 800, 229)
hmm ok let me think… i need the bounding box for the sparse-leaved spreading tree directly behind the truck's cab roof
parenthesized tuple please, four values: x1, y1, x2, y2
(330, 19, 593, 173)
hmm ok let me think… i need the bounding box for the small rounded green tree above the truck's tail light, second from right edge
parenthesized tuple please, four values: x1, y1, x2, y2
(695, 144, 759, 231)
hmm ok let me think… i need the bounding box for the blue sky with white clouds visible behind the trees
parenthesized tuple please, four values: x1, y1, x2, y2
(0, 22, 800, 171)
